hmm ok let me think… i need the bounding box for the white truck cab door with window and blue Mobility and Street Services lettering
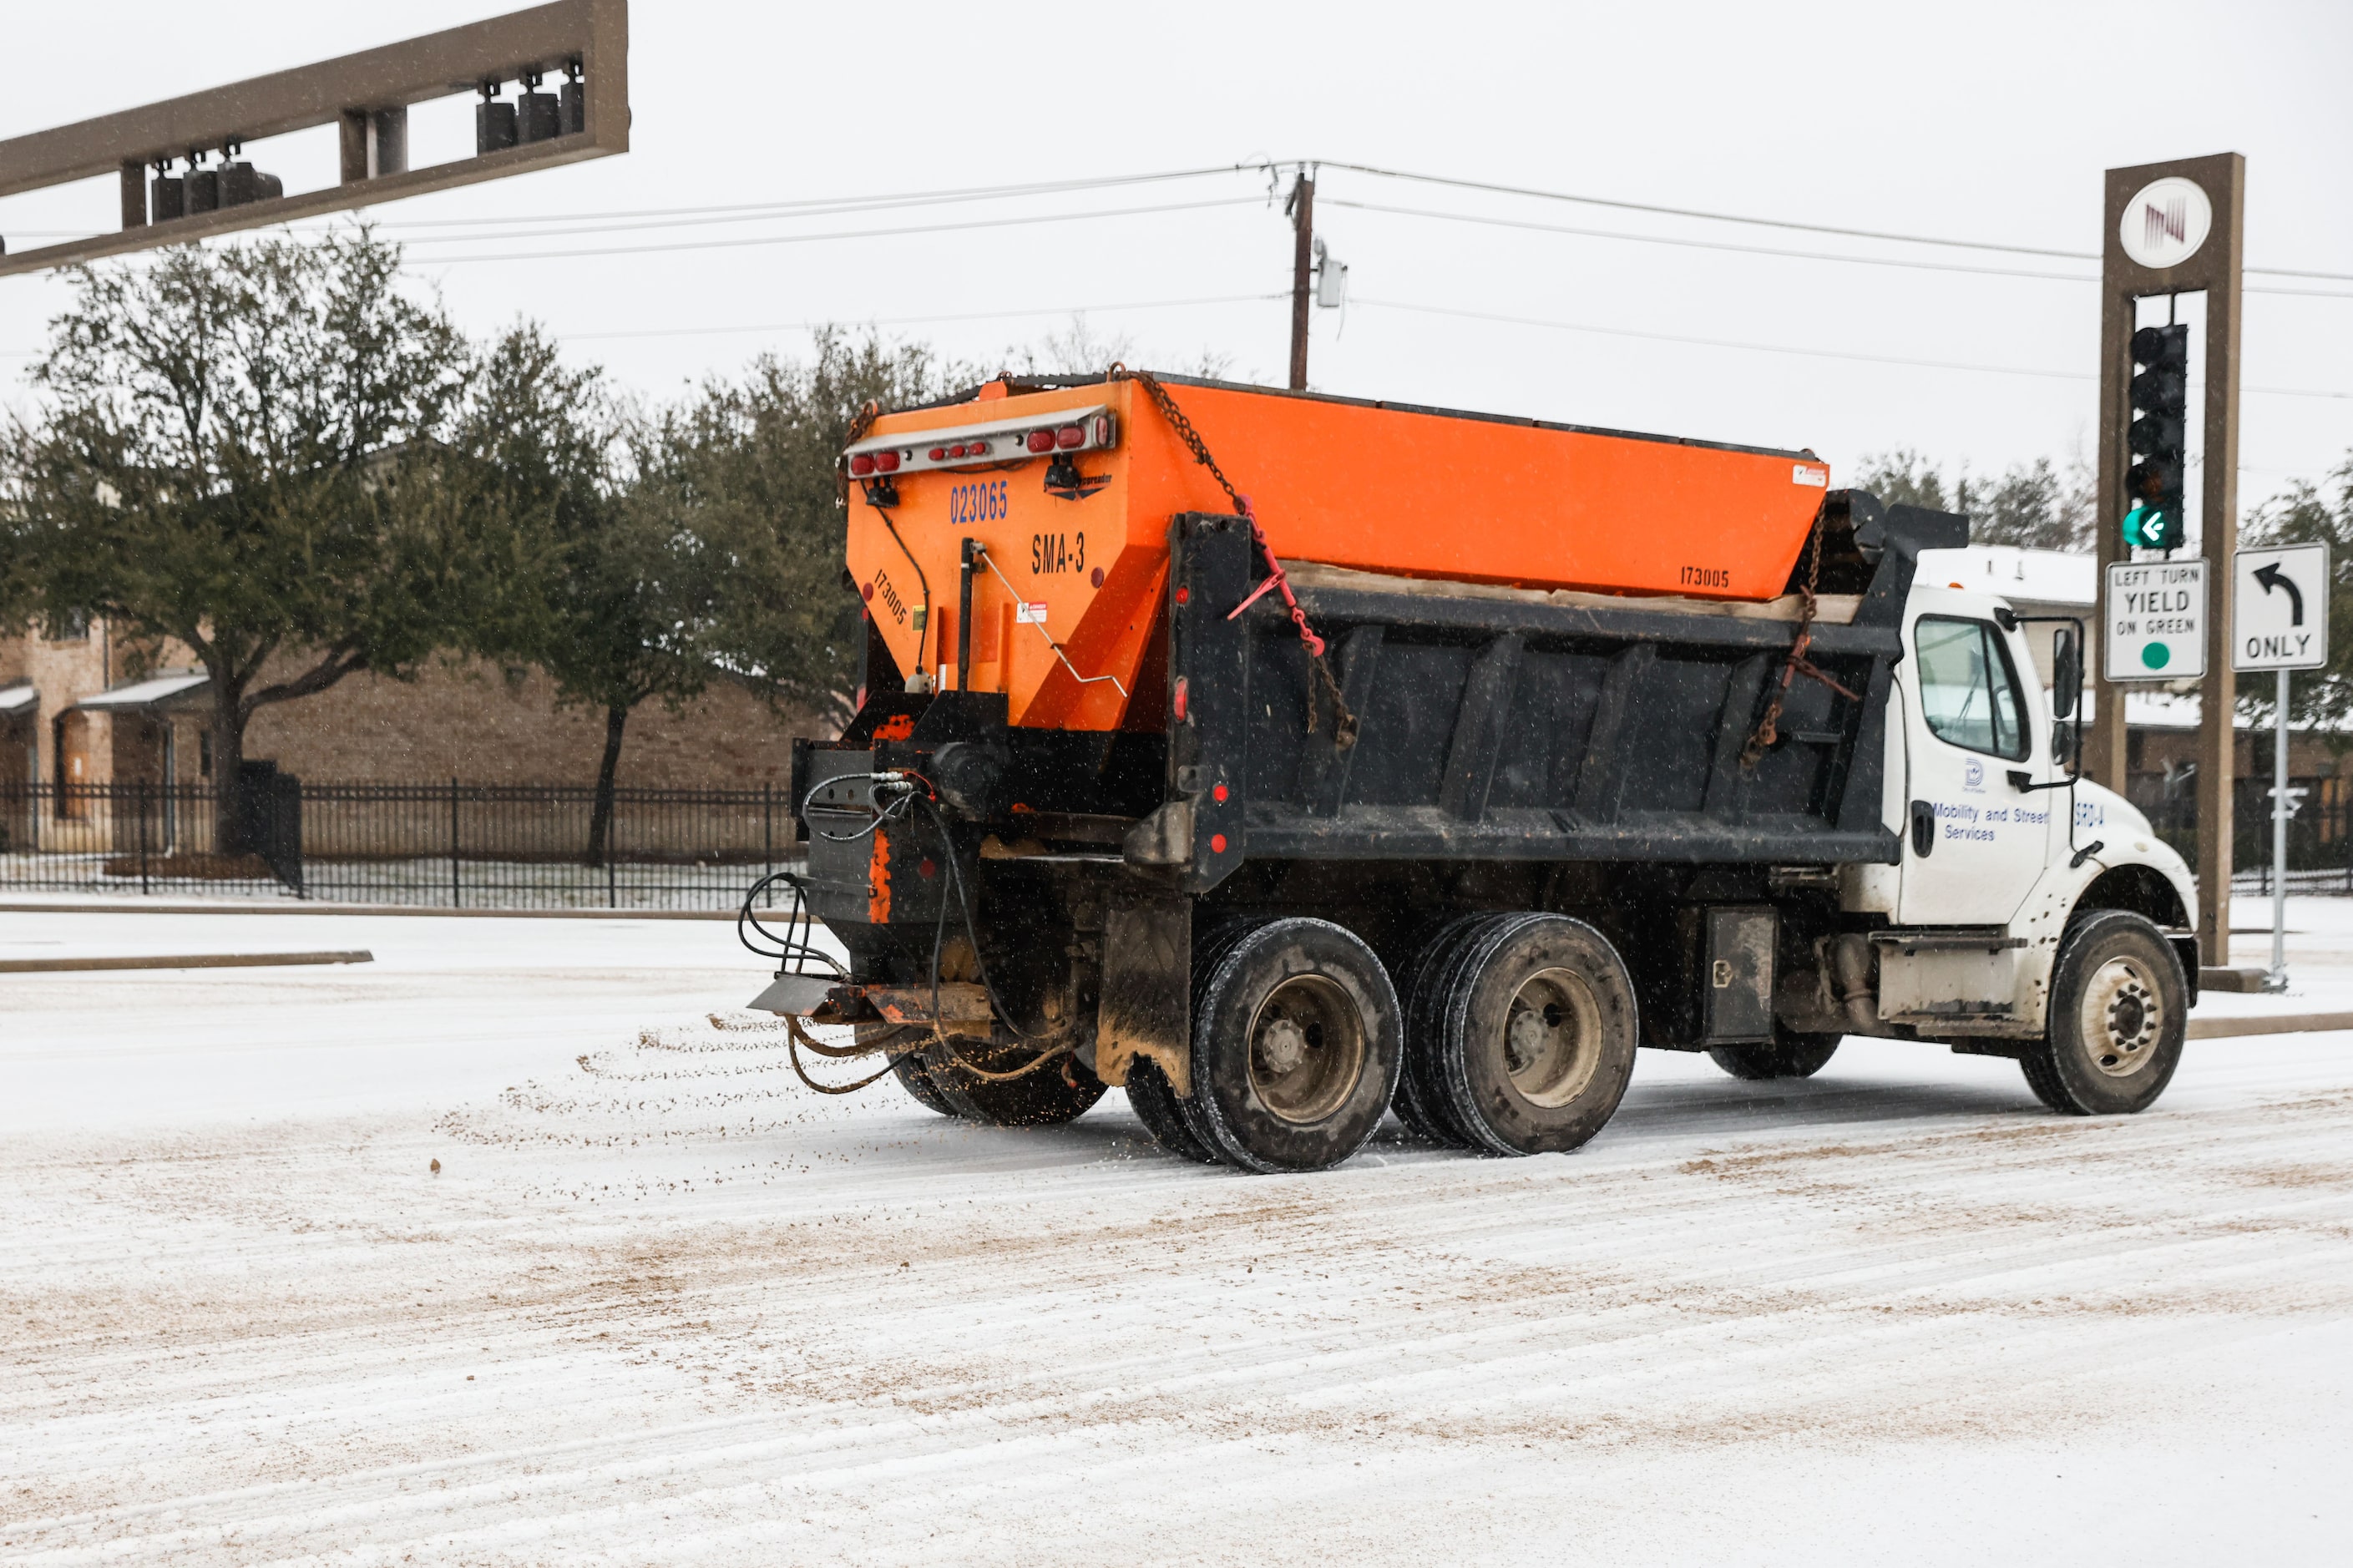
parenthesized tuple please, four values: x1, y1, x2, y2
(1896, 612, 2066, 925)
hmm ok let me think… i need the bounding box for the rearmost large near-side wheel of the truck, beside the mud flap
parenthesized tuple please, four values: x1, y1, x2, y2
(1188, 918, 1403, 1170)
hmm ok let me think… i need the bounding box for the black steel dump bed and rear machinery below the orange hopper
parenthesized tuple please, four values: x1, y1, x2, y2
(795, 492, 1967, 930)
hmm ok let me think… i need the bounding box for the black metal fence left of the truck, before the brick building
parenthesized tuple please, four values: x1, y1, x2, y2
(0, 775, 802, 908)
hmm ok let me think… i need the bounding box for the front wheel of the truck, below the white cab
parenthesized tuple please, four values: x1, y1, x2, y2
(2019, 908, 2189, 1116)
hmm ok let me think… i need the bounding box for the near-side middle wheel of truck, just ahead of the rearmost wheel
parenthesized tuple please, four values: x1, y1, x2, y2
(1416, 913, 1640, 1154)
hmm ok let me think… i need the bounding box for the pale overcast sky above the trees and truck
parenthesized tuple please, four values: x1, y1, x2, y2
(0, 0, 2353, 513)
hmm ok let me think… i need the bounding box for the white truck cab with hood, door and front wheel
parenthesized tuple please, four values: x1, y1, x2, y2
(1798, 581, 2198, 1111)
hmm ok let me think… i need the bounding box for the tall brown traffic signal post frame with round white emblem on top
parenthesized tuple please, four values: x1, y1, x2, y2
(2085, 153, 2247, 965)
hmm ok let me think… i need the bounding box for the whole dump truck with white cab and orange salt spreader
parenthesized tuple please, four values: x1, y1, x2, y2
(753, 367, 2198, 1172)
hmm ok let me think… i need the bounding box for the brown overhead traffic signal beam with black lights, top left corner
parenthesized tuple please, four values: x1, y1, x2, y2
(0, 0, 628, 276)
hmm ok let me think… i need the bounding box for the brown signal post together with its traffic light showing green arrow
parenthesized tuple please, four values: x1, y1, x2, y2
(2085, 153, 2247, 965)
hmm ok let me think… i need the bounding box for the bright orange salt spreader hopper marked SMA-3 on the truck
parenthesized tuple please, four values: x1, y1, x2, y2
(845, 377, 1830, 730)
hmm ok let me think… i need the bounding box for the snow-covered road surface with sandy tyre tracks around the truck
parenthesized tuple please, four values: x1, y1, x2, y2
(0, 899, 2353, 1563)
